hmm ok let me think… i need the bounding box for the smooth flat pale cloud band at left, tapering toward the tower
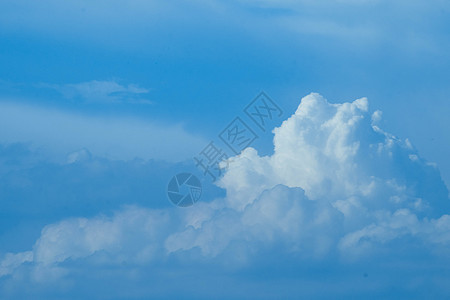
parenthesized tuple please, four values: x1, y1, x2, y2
(0, 102, 206, 161)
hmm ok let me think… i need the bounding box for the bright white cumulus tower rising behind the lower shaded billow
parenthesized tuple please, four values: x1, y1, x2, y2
(220, 94, 448, 214)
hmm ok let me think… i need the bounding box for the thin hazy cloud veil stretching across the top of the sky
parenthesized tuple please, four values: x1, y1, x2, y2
(0, 0, 450, 51)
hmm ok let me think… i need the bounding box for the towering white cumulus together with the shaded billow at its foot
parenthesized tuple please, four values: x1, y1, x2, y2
(164, 94, 449, 255)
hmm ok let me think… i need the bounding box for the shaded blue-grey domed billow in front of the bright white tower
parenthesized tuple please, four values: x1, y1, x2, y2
(165, 185, 342, 260)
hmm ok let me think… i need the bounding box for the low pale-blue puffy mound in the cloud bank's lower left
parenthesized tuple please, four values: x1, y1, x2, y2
(33, 207, 169, 266)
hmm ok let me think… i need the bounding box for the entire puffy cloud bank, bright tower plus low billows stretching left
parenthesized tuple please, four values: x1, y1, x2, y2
(0, 94, 450, 298)
